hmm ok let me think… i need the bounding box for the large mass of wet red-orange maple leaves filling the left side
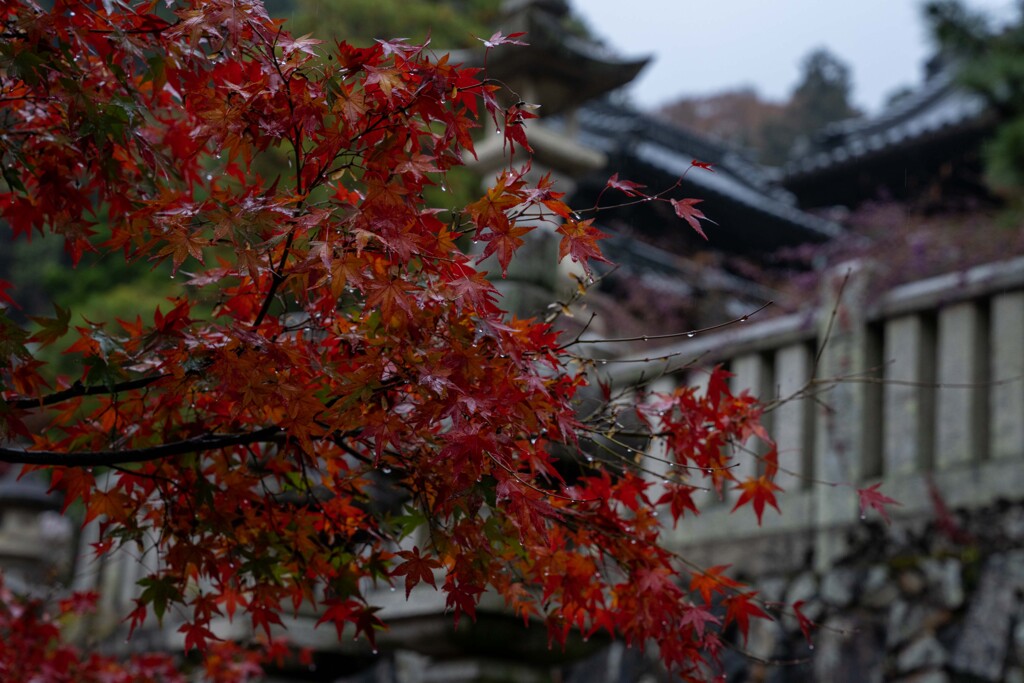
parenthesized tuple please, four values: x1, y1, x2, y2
(0, 0, 864, 677)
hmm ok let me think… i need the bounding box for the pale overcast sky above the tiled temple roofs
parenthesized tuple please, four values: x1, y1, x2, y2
(571, 0, 1013, 112)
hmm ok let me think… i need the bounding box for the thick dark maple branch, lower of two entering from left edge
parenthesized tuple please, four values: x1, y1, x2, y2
(0, 427, 285, 467)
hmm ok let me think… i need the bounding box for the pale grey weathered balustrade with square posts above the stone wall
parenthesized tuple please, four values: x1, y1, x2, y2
(612, 259, 1024, 571)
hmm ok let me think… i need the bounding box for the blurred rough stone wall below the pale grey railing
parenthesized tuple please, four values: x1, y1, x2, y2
(726, 501, 1024, 683)
